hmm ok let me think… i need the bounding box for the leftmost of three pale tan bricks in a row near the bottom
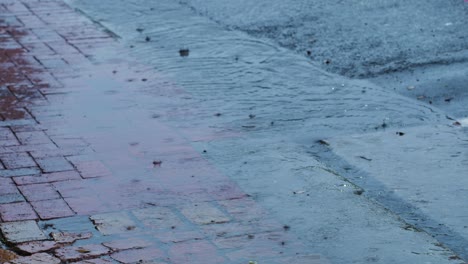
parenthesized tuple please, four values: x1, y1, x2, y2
(90, 212, 138, 235)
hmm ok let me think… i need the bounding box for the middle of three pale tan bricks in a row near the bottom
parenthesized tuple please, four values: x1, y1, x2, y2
(132, 207, 184, 230)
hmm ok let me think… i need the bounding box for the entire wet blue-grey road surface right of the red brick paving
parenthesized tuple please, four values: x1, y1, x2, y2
(68, 0, 468, 263)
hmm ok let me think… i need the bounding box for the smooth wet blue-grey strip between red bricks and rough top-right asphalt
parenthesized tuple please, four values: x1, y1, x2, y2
(65, 1, 468, 263)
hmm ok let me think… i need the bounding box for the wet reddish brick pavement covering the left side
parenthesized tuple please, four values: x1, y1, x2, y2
(0, 0, 325, 264)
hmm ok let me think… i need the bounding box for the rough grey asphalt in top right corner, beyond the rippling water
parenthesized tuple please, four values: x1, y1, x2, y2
(181, 0, 468, 117)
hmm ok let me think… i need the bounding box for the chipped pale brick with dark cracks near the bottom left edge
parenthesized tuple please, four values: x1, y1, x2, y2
(55, 244, 110, 261)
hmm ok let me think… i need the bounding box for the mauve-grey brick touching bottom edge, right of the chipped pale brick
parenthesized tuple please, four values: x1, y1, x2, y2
(111, 247, 166, 263)
